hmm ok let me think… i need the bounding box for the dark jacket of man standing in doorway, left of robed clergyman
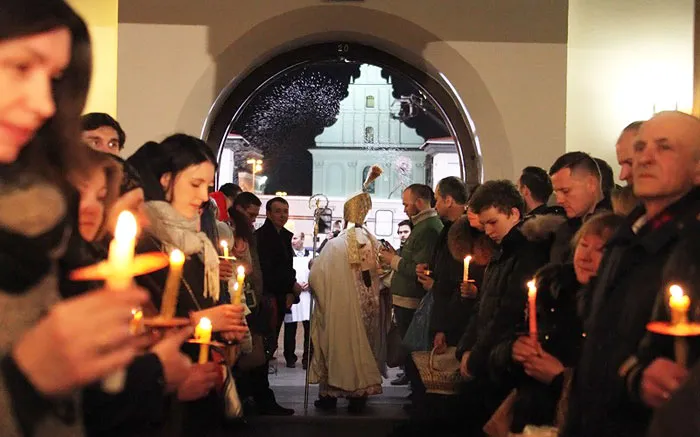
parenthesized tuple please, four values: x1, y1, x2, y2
(255, 219, 296, 299)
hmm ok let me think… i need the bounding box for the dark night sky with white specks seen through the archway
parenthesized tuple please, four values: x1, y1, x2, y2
(233, 62, 448, 196)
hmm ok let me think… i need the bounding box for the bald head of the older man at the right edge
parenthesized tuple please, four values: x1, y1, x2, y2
(632, 111, 700, 209)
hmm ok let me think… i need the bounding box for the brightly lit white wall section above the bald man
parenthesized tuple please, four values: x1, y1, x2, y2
(566, 0, 696, 181)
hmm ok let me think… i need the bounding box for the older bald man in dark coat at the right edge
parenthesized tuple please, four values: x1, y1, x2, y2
(563, 112, 700, 437)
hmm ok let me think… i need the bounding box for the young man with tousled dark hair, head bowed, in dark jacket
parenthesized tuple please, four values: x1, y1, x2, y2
(457, 180, 548, 432)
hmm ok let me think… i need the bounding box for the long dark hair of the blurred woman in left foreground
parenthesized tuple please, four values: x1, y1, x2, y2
(0, 0, 92, 183)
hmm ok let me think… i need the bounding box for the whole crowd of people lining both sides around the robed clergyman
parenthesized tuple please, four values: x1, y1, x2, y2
(0, 0, 700, 437)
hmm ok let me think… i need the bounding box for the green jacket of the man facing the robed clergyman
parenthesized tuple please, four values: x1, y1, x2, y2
(391, 209, 443, 308)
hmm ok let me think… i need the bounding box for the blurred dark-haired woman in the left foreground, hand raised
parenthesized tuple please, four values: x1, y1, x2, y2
(0, 0, 147, 437)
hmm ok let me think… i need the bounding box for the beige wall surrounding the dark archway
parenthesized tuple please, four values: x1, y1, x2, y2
(118, 0, 567, 178)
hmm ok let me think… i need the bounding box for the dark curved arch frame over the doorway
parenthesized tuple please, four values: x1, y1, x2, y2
(202, 41, 482, 186)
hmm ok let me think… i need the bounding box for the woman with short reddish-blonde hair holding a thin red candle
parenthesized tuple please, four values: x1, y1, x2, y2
(486, 213, 624, 434)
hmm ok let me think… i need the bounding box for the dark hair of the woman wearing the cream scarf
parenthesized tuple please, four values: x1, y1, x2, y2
(126, 134, 217, 200)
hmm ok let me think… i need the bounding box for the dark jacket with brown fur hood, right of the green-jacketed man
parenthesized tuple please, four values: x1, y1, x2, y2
(430, 216, 488, 346)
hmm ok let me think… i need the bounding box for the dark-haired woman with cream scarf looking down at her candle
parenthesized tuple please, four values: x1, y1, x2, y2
(127, 134, 246, 435)
